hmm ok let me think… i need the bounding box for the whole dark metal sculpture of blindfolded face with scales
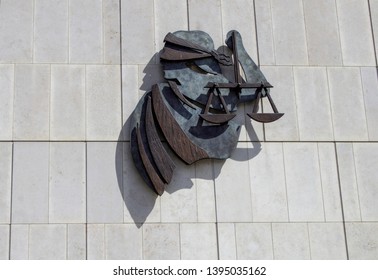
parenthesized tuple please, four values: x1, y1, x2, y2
(130, 31, 283, 195)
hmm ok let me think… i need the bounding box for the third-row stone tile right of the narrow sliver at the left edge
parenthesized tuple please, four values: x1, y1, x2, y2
(12, 142, 49, 223)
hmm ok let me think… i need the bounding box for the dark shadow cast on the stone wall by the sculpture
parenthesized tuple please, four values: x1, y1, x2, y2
(115, 53, 261, 228)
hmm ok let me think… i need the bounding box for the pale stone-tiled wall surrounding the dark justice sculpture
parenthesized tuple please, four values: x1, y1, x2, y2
(0, 0, 378, 259)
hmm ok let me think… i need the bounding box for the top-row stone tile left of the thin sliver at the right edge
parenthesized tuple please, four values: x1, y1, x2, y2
(336, 0, 375, 66)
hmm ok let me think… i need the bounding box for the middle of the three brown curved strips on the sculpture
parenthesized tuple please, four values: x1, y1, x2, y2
(146, 97, 175, 183)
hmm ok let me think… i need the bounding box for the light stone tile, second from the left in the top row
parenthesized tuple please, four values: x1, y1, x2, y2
(34, 0, 68, 63)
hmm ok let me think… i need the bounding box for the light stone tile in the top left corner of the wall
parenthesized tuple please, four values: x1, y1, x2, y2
(0, 0, 33, 63)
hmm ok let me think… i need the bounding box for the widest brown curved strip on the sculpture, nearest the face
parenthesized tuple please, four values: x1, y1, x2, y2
(152, 84, 209, 164)
